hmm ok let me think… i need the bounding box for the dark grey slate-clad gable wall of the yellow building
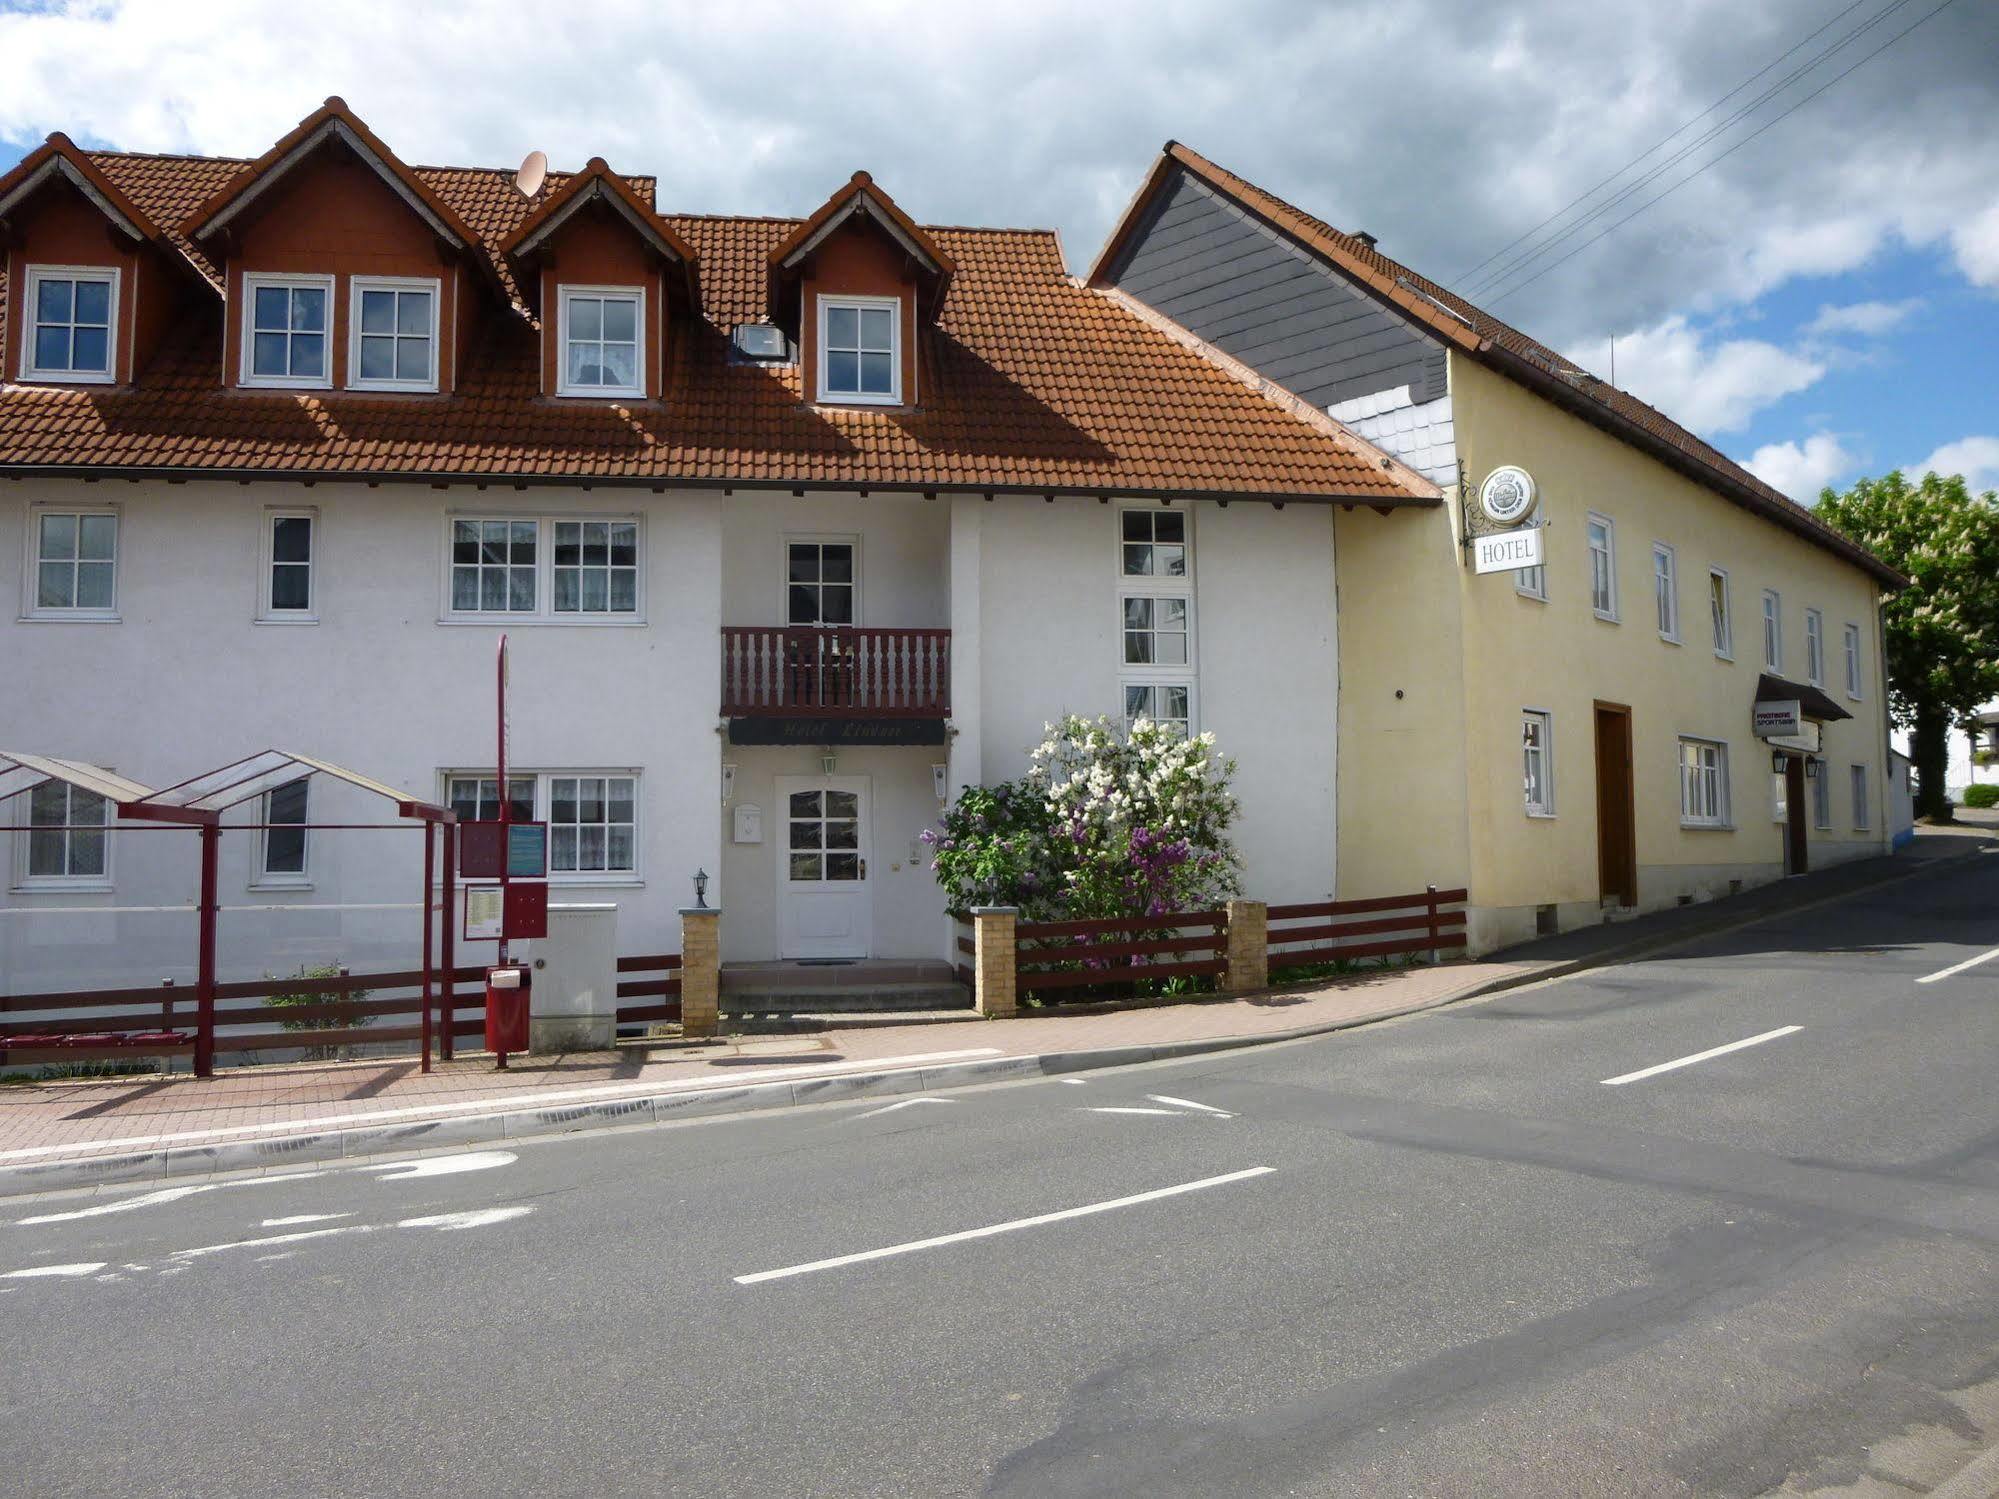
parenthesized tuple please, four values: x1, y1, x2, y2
(1105, 166, 1445, 410)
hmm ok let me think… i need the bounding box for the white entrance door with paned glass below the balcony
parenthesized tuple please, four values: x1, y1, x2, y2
(778, 775, 874, 957)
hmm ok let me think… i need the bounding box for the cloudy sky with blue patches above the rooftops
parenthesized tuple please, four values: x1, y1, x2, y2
(0, 0, 1999, 502)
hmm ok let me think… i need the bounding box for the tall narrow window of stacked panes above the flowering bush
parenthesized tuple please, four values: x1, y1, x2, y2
(1117, 506, 1195, 734)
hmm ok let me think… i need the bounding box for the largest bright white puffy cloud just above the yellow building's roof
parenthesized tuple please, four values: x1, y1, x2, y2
(1571, 316, 1825, 434)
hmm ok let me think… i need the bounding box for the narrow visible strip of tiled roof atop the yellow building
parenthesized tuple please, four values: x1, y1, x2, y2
(1089, 140, 1909, 588)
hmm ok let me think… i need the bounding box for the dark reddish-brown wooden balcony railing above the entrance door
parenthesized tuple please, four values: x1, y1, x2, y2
(722, 626, 952, 718)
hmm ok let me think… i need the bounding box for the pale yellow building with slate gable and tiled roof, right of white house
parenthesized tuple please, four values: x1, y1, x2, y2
(1089, 142, 1903, 949)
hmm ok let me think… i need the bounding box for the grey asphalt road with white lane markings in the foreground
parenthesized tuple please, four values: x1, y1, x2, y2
(0, 855, 1999, 1497)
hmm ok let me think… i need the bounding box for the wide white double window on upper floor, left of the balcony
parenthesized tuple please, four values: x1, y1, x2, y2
(444, 516, 644, 624)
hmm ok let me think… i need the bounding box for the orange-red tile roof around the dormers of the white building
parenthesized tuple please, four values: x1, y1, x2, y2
(0, 131, 1437, 506)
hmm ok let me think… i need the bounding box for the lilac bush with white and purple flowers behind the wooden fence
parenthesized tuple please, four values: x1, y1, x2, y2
(926, 716, 1241, 921)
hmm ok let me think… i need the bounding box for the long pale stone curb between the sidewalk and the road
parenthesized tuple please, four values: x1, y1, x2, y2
(0, 849, 1983, 1207)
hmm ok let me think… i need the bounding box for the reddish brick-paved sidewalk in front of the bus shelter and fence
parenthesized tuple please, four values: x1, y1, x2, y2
(0, 963, 1539, 1165)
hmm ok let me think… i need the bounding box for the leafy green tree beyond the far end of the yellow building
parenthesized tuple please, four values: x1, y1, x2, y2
(1819, 470, 1999, 817)
